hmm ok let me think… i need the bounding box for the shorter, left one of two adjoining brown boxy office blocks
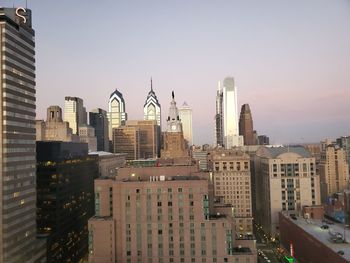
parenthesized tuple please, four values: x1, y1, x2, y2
(112, 126, 140, 160)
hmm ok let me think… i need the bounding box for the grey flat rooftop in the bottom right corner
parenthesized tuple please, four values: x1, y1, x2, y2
(284, 214, 350, 262)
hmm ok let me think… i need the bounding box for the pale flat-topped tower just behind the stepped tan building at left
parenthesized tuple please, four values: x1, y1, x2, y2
(64, 97, 87, 135)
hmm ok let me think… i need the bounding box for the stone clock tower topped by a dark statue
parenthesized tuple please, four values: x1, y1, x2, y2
(161, 92, 189, 159)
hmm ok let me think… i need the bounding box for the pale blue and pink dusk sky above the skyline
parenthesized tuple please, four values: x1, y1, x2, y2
(0, 0, 350, 144)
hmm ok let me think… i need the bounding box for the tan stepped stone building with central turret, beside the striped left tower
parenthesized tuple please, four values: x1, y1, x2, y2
(35, 106, 79, 142)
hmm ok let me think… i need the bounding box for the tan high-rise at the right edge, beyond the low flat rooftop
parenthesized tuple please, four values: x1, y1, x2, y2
(317, 141, 349, 202)
